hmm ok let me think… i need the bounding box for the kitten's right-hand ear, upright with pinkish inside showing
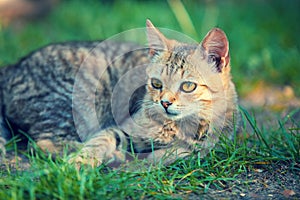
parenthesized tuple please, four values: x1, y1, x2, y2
(201, 28, 230, 72)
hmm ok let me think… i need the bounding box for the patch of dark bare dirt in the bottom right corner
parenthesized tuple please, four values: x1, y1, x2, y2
(203, 162, 300, 200)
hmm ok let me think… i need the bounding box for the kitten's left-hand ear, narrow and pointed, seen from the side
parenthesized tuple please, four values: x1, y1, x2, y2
(146, 19, 168, 56)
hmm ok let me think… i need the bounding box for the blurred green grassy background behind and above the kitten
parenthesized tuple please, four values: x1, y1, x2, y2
(0, 0, 300, 96)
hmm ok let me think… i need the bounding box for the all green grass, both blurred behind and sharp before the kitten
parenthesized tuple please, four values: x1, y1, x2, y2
(0, 0, 300, 199)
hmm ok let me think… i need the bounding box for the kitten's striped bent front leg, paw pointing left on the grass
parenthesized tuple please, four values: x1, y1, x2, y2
(70, 127, 128, 167)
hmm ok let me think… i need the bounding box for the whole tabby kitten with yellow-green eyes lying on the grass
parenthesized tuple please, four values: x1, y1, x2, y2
(0, 20, 238, 165)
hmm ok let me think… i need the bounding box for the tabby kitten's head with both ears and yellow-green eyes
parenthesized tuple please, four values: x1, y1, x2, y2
(146, 20, 230, 120)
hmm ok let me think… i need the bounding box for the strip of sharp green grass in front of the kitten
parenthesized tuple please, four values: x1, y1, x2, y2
(0, 110, 300, 199)
